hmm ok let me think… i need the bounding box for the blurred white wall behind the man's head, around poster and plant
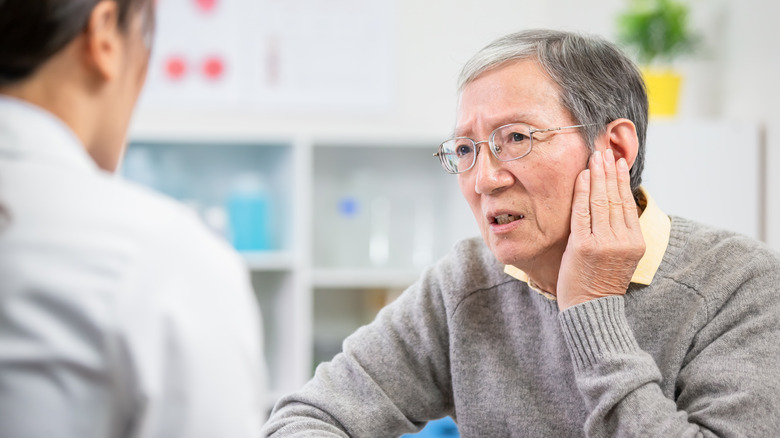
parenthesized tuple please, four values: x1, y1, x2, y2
(133, 0, 780, 249)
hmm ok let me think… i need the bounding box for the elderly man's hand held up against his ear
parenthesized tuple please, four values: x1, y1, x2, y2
(556, 149, 645, 311)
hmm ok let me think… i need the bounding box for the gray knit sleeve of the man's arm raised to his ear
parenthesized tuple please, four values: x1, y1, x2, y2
(559, 280, 780, 437)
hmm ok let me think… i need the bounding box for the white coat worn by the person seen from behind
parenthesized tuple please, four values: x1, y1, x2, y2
(0, 97, 264, 438)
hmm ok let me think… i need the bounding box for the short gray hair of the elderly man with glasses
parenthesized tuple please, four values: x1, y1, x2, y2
(458, 30, 647, 197)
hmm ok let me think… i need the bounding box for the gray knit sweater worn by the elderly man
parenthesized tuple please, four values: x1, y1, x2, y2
(263, 217, 780, 438)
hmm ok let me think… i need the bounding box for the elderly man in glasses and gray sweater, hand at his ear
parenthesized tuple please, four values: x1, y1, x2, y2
(264, 31, 780, 437)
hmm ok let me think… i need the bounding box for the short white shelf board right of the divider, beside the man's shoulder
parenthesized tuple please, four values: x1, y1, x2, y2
(312, 268, 421, 289)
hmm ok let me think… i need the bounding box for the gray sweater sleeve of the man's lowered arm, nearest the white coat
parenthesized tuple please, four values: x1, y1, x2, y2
(263, 272, 452, 437)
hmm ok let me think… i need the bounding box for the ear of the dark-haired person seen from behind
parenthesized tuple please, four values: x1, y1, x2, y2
(84, 1, 122, 80)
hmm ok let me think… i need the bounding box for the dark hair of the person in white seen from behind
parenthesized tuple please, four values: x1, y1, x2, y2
(0, 0, 152, 86)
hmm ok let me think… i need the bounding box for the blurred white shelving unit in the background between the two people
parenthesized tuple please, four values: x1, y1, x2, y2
(123, 130, 477, 408)
